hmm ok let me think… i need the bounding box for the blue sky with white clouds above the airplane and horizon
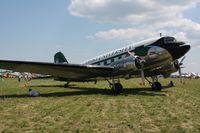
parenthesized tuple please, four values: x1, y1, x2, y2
(0, 0, 200, 73)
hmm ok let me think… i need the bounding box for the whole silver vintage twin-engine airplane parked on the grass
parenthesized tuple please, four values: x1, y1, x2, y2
(0, 36, 190, 94)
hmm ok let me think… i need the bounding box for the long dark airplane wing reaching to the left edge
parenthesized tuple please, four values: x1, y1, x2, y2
(0, 60, 114, 81)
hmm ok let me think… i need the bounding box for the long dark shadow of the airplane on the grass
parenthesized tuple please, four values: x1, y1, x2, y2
(1, 85, 171, 98)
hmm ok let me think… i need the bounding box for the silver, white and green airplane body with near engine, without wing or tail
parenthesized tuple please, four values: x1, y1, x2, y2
(84, 36, 190, 76)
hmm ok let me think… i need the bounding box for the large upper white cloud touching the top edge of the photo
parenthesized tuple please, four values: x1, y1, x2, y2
(68, 0, 199, 24)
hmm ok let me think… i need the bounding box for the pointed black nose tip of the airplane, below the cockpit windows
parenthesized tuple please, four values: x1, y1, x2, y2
(170, 45, 190, 60)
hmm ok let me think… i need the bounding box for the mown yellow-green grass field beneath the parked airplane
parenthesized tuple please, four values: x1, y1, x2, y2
(0, 79, 200, 133)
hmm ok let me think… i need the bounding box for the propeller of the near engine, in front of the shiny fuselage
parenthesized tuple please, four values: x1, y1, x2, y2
(127, 51, 145, 86)
